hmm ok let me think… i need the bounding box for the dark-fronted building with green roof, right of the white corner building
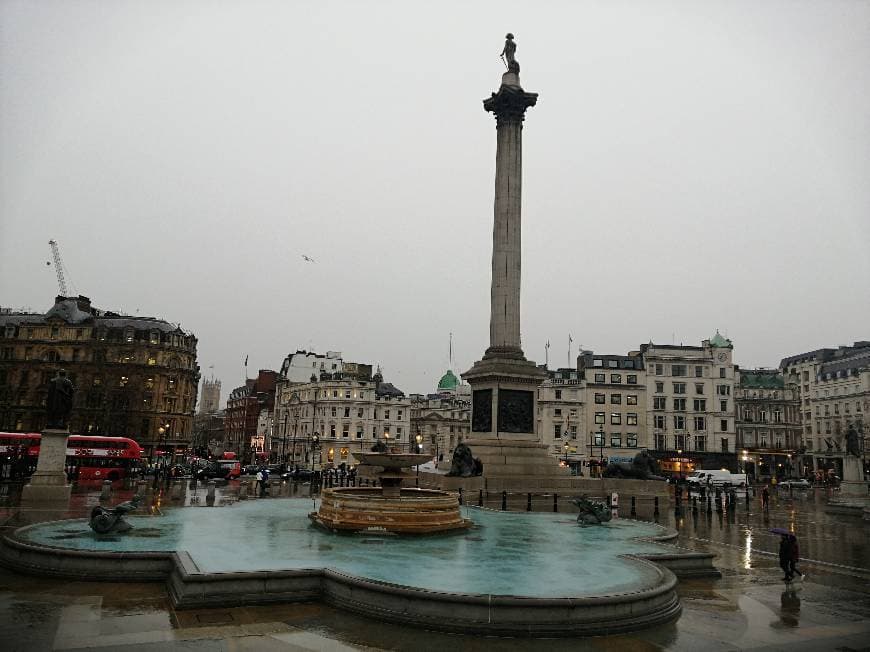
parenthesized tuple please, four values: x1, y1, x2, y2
(734, 369, 805, 480)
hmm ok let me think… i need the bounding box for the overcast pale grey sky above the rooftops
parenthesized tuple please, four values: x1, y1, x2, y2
(0, 0, 870, 402)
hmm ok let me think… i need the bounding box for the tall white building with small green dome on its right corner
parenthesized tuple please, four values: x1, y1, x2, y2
(640, 332, 738, 476)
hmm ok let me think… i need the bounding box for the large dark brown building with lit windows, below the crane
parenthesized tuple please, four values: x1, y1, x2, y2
(0, 296, 199, 455)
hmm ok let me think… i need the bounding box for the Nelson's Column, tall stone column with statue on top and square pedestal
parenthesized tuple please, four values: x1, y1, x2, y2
(462, 34, 562, 479)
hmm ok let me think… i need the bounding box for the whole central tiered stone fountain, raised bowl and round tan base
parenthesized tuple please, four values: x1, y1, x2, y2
(309, 453, 471, 534)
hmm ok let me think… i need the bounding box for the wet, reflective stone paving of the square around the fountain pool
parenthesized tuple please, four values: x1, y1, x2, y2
(0, 482, 870, 652)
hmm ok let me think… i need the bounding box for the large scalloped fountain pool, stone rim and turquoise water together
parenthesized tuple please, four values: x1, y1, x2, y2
(0, 499, 717, 636)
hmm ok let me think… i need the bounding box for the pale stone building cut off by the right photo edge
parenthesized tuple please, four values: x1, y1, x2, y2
(780, 341, 870, 477)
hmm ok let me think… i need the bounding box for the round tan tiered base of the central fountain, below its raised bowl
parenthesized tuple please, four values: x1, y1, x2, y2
(309, 487, 471, 534)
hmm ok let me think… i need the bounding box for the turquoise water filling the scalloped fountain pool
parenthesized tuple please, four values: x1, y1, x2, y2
(21, 499, 672, 597)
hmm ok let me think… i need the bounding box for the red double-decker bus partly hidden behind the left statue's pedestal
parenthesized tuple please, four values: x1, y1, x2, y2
(0, 432, 142, 482)
